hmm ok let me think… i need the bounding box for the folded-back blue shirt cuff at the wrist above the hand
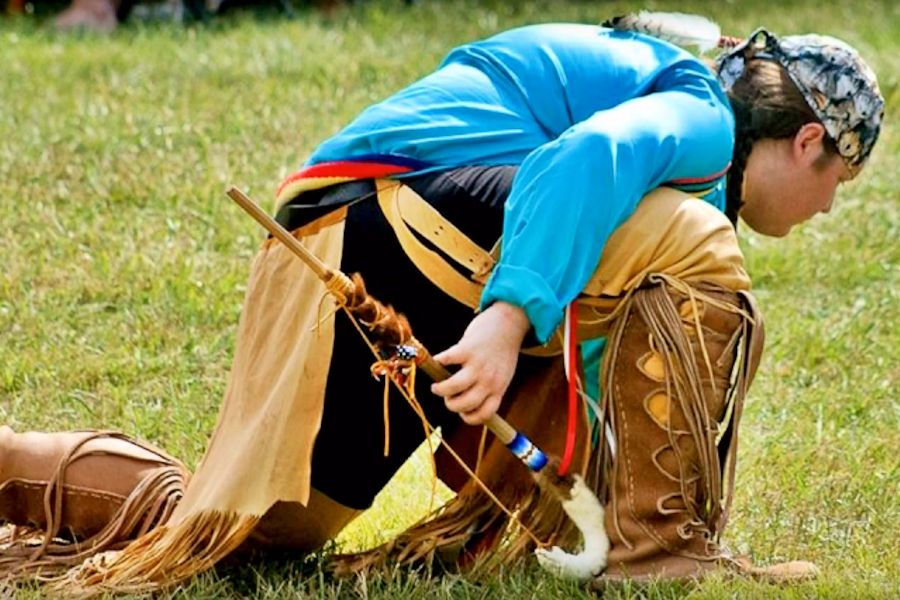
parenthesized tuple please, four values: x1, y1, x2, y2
(481, 264, 562, 344)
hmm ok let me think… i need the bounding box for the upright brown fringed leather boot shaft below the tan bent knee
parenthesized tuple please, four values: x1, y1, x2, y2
(603, 283, 750, 580)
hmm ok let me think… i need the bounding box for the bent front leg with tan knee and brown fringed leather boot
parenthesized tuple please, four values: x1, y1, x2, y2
(588, 190, 816, 586)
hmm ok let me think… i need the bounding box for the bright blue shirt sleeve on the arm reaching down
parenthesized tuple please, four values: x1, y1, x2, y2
(482, 70, 734, 342)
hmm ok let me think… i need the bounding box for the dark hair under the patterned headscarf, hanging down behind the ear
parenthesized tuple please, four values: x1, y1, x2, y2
(725, 56, 837, 224)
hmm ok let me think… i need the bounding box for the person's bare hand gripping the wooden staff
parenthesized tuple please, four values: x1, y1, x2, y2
(431, 302, 531, 425)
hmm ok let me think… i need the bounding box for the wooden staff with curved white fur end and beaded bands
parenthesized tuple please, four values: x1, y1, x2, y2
(226, 187, 609, 579)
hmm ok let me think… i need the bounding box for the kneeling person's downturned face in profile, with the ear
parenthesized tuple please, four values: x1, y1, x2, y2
(740, 123, 851, 237)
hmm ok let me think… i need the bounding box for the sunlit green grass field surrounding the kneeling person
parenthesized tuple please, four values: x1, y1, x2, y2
(0, 0, 900, 599)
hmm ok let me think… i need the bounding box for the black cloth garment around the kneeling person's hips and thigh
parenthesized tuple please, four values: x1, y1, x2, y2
(278, 167, 514, 509)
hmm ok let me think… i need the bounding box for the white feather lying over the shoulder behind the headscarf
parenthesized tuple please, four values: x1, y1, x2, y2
(603, 10, 722, 52)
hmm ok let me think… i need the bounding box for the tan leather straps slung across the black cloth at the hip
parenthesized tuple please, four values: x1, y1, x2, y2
(375, 179, 494, 309)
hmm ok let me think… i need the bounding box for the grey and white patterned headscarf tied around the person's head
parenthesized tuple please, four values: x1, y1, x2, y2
(717, 29, 884, 176)
